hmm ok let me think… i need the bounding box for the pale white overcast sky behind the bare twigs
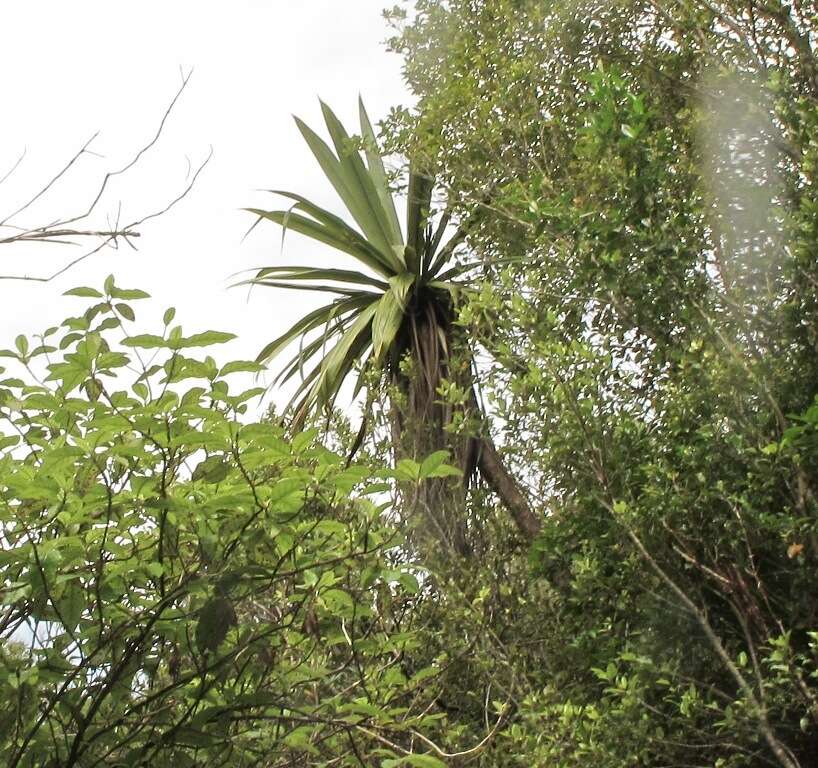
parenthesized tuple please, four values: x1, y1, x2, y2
(0, 0, 411, 404)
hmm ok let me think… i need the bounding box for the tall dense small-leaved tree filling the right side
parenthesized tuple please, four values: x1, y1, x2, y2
(387, 0, 818, 768)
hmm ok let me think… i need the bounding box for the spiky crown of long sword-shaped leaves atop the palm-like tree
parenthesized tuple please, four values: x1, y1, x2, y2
(242, 103, 464, 423)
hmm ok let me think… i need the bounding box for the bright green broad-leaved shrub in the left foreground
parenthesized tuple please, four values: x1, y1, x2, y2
(0, 278, 443, 767)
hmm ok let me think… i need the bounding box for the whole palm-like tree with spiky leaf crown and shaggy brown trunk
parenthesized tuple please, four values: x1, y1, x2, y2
(247, 103, 539, 551)
